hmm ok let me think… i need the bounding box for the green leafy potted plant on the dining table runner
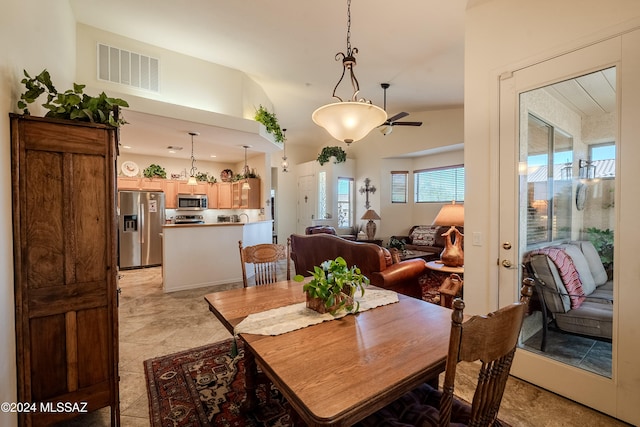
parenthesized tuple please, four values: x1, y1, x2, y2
(294, 257, 369, 316)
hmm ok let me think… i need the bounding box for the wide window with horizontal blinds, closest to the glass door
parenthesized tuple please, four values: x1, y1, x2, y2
(413, 165, 464, 203)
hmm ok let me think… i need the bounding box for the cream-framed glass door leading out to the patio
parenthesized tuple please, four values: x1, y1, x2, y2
(498, 31, 640, 423)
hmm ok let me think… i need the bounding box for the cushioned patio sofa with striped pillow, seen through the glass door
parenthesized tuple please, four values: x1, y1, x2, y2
(525, 241, 613, 351)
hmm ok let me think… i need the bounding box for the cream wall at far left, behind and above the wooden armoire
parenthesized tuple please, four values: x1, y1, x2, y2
(0, 0, 76, 426)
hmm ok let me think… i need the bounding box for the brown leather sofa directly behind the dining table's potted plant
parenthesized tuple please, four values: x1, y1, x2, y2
(291, 234, 427, 298)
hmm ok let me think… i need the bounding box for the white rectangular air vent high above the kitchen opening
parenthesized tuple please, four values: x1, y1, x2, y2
(98, 43, 160, 92)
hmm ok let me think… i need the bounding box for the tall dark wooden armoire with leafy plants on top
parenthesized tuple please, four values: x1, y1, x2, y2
(10, 114, 120, 426)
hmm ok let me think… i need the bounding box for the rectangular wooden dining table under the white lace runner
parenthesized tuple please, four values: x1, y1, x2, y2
(205, 281, 451, 426)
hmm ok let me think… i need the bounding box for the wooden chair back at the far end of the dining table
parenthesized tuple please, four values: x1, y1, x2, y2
(238, 239, 291, 288)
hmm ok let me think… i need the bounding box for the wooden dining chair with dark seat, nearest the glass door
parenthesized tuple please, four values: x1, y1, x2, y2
(358, 278, 533, 427)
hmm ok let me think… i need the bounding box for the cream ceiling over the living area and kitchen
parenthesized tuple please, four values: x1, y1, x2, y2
(70, 0, 467, 162)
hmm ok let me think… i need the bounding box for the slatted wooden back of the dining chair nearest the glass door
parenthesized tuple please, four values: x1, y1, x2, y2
(439, 278, 533, 426)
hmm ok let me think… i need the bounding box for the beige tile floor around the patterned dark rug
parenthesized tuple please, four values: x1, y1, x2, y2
(57, 267, 627, 427)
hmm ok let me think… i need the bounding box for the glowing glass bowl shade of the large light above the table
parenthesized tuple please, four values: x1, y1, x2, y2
(311, 101, 387, 144)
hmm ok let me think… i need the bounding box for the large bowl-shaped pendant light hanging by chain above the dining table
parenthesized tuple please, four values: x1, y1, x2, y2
(311, 0, 387, 145)
